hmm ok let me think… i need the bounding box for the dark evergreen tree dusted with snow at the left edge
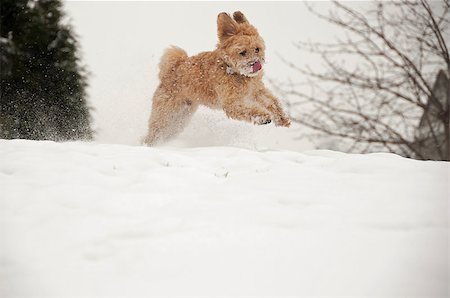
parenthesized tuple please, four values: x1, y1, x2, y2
(0, 0, 93, 141)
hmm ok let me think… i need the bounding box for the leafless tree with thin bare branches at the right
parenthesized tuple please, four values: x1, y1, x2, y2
(277, 0, 450, 160)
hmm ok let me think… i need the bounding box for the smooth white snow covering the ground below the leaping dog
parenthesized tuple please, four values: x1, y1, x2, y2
(0, 140, 449, 297)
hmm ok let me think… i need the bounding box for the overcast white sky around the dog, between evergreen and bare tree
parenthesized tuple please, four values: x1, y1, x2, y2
(65, 1, 363, 150)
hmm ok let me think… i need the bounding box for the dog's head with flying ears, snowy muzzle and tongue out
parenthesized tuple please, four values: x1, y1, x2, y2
(217, 11, 265, 77)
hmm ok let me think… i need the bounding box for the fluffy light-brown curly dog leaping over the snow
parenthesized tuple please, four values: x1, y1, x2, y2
(144, 11, 290, 146)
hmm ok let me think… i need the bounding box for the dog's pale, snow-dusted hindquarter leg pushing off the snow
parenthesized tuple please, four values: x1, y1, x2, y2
(144, 88, 198, 146)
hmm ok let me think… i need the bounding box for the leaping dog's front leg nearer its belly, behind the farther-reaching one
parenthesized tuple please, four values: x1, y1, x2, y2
(222, 97, 272, 125)
